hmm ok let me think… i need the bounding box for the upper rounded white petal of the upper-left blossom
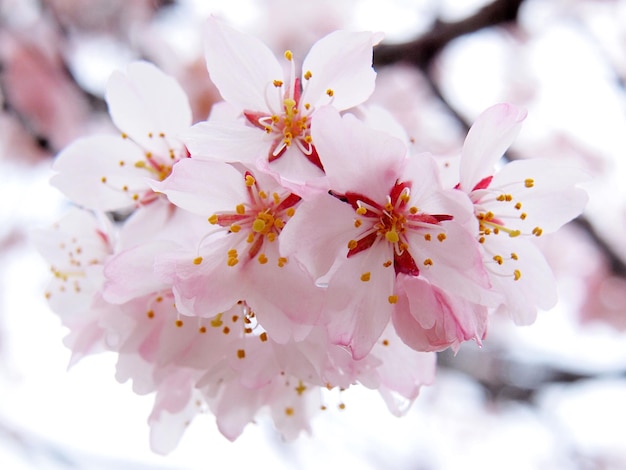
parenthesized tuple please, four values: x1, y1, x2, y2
(106, 62, 191, 155)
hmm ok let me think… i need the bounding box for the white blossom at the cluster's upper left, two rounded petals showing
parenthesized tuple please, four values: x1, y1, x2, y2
(52, 62, 191, 211)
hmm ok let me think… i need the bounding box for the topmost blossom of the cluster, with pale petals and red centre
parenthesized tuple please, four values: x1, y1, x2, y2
(186, 18, 381, 187)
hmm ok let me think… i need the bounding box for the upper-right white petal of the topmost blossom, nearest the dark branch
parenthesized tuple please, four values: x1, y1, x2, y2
(302, 31, 382, 110)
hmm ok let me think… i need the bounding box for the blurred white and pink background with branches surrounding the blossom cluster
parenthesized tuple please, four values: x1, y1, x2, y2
(0, 0, 626, 470)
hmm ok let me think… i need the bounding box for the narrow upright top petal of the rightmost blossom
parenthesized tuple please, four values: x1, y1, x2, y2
(460, 103, 526, 192)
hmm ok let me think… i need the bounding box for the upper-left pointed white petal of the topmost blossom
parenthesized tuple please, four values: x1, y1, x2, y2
(205, 18, 283, 111)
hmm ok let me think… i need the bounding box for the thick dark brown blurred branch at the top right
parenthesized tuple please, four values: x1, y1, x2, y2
(374, 0, 523, 70)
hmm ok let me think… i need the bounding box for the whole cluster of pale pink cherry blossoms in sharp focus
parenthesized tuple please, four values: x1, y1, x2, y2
(38, 19, 586, 453)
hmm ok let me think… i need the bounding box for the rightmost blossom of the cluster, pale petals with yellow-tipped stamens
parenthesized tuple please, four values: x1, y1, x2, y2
(458, 104, 587, 324)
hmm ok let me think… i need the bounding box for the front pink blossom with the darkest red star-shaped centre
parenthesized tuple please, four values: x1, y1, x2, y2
(281, 108, 489, 359)
